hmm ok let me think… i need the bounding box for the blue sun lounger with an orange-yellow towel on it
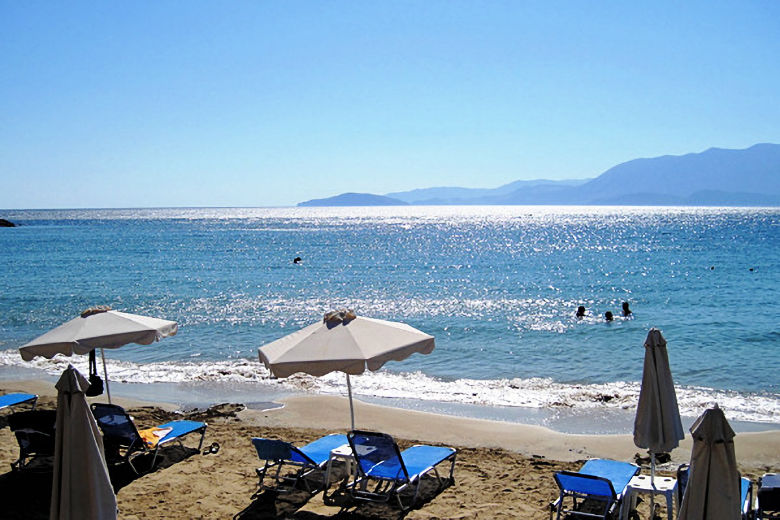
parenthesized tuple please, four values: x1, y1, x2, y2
(90, 403, 207, 473)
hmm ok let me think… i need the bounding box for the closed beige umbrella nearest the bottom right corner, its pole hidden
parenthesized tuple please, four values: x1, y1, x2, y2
(678, 405, 742, 520)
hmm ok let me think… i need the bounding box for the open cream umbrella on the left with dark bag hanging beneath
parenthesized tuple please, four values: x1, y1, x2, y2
(19, 307, 178, 403)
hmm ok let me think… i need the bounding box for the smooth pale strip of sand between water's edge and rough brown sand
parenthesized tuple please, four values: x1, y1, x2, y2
(0, 380, 780, 469)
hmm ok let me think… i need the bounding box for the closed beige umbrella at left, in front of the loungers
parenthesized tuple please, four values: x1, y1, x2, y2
(49, 365, 117, 520)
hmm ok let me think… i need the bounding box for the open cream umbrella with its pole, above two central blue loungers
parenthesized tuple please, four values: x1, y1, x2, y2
(259, 311, 435, 430)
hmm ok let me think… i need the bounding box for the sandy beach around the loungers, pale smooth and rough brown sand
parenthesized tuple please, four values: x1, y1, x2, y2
(0, 381, 780, 520)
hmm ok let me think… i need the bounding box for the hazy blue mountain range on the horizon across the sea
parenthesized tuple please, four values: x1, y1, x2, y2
(298, 143, 780, 206)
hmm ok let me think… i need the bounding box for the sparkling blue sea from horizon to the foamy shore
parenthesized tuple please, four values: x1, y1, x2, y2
(0, 206, 780, 433)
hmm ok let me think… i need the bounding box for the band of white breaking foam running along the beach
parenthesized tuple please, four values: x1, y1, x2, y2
(0, 350, 780, 424)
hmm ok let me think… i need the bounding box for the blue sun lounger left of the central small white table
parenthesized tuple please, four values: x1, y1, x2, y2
(252, 434, 347, 493)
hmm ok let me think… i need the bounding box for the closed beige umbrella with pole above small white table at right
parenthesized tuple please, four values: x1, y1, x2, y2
(634, 329, 685, 508)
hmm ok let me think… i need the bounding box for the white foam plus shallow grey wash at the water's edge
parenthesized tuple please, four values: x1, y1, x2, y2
(0, 349, 780, 428)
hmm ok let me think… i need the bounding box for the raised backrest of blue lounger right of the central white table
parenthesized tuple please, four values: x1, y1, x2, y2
(347, 430, 409, 481)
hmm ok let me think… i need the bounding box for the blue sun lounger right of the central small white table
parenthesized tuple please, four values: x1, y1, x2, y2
(347, 431, 457, 510)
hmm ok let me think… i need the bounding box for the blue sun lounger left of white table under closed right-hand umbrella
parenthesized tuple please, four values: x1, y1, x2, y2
(551, 459, 639, 519)
